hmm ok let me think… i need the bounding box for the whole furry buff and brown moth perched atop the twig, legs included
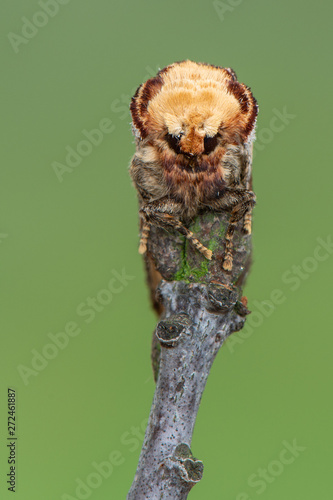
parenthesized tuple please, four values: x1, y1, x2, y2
(130, 60, 258, 272)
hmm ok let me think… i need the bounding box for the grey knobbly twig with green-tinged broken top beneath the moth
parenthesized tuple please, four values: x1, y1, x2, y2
(127, 209, 251, 500)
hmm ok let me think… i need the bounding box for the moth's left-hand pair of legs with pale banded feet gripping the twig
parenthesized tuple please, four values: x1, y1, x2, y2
(139, 200, 212, 260)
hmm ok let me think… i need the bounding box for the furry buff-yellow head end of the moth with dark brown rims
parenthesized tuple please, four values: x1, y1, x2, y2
(130, 61, 258, 157)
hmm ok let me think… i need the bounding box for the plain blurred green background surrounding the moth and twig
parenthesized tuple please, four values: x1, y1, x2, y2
(0, 0, 333, 500)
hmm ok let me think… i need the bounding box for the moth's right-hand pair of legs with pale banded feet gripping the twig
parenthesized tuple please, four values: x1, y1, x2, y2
(211, 189, 255, 271)
